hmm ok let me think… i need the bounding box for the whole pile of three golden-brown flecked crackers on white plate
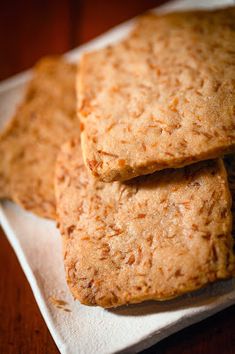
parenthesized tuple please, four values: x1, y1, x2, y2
(0, 7, 235, 307)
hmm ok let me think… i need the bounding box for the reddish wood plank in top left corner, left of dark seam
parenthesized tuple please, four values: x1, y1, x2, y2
(0, 0, 71, 79)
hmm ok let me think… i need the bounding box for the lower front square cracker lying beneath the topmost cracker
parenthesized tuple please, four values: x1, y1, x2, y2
(55, 142, 234, 307)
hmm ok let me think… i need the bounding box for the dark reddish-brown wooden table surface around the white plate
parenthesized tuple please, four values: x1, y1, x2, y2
(0, 0, 235, 354)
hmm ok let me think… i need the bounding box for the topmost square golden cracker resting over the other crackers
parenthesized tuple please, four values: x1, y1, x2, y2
(77, 8, 235, 181)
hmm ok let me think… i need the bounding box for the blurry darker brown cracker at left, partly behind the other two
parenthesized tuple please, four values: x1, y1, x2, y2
(0, 58, 79, 218)
